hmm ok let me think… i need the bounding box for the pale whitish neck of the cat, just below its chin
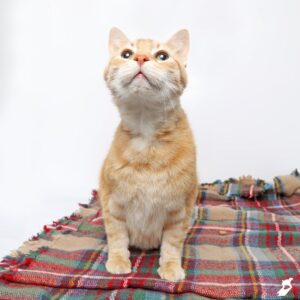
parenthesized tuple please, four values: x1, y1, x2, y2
(118, 98, 181, 138)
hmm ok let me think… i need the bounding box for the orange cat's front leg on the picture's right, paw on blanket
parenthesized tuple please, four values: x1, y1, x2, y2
(157, 221, 186, 281)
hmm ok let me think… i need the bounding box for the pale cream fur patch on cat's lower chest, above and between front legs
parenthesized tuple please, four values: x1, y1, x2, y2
(109, 170, 185, 249)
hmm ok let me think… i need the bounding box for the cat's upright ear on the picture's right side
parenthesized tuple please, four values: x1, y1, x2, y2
(166, 29, 190, 66)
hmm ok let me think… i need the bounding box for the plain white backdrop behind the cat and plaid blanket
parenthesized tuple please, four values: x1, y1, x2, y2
(0, 0, 300, 256)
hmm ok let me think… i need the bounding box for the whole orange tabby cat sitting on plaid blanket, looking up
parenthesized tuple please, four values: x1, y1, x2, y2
(100, 28, 198, 281)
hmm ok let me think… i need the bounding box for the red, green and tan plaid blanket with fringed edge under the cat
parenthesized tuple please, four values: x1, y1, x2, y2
(0, 173, 300, 299)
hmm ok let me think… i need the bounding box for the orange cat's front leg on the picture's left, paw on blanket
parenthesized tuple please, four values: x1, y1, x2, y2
(105, 206, 131, 274)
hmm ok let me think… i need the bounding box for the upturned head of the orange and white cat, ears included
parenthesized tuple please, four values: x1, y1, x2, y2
(104, 28, 189, 104)
